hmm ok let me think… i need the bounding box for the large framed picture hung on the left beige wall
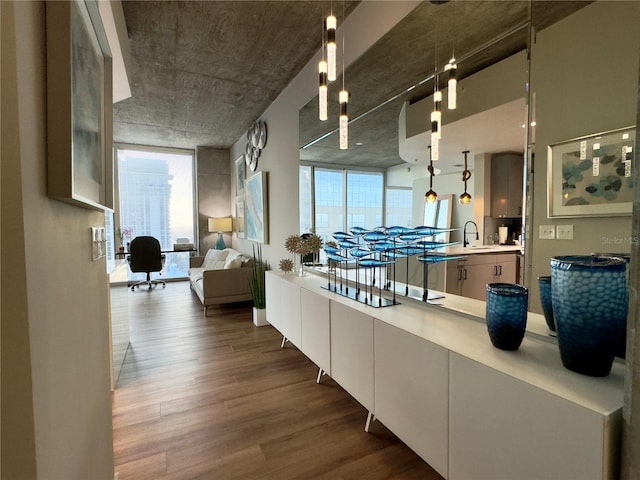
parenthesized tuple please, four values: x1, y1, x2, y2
(45, 0, 113, 210)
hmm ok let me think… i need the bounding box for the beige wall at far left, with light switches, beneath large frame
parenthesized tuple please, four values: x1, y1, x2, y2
(1, 2, 113, 479)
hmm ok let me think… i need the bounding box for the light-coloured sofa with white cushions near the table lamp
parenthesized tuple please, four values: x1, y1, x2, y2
(189, 248, 252, 315)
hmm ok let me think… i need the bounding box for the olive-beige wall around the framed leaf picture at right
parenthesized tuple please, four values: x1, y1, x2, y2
(527, 2, 640, 313)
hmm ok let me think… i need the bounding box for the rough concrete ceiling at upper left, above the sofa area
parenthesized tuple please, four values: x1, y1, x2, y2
(114, 0, 359, 148)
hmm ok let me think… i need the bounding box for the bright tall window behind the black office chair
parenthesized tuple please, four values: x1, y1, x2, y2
(116, 146, 195, 278)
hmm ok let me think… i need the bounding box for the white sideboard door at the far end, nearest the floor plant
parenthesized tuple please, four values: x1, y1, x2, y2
(265, 272, 301, 348)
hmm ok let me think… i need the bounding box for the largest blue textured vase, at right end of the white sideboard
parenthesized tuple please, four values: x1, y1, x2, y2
(551, 255, 629, 377)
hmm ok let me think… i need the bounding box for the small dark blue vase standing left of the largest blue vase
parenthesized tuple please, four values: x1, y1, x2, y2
(486, 283, 529, 350)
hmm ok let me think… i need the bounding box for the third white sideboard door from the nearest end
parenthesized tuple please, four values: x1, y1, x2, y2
(331, 301, 374, 412)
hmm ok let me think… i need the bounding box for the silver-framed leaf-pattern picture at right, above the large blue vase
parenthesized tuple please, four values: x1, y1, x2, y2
(547, 126, 636, 218)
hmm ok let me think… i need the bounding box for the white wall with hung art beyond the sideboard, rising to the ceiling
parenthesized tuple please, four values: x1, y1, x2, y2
(230, 1, 420, 268)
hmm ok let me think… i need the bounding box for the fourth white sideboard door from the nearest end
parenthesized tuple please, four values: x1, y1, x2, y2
(300, 288, 331, 375)
